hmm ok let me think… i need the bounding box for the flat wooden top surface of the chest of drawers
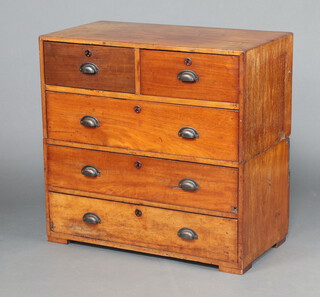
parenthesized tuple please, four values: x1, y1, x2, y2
(41, 21, 287, 55)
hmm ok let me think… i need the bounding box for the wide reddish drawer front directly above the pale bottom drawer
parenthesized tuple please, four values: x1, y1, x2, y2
(47, 145, 238, 213)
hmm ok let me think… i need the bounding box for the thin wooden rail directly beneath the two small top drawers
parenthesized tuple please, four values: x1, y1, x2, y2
(45, 85, 239, 110)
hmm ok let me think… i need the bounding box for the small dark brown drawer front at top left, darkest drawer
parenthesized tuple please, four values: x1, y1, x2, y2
(44, 42, 135, 93)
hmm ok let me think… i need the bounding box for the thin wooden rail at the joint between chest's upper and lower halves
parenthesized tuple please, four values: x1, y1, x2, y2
(45, 139, 239, 168)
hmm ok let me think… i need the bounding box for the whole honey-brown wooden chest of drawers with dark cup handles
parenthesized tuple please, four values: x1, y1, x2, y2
(40, 22, 292, 274)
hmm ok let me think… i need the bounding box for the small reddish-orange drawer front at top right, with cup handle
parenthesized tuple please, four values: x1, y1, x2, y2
(141, 50, 239, 102)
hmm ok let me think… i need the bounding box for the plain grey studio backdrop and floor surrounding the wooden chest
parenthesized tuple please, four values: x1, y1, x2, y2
(0, 0, 320, 297)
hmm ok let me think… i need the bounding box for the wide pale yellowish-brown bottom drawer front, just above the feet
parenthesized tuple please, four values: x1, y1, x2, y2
(49, 193, 237, 262)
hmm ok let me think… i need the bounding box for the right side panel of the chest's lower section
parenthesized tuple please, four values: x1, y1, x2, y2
(239, 140, 289, 265)
